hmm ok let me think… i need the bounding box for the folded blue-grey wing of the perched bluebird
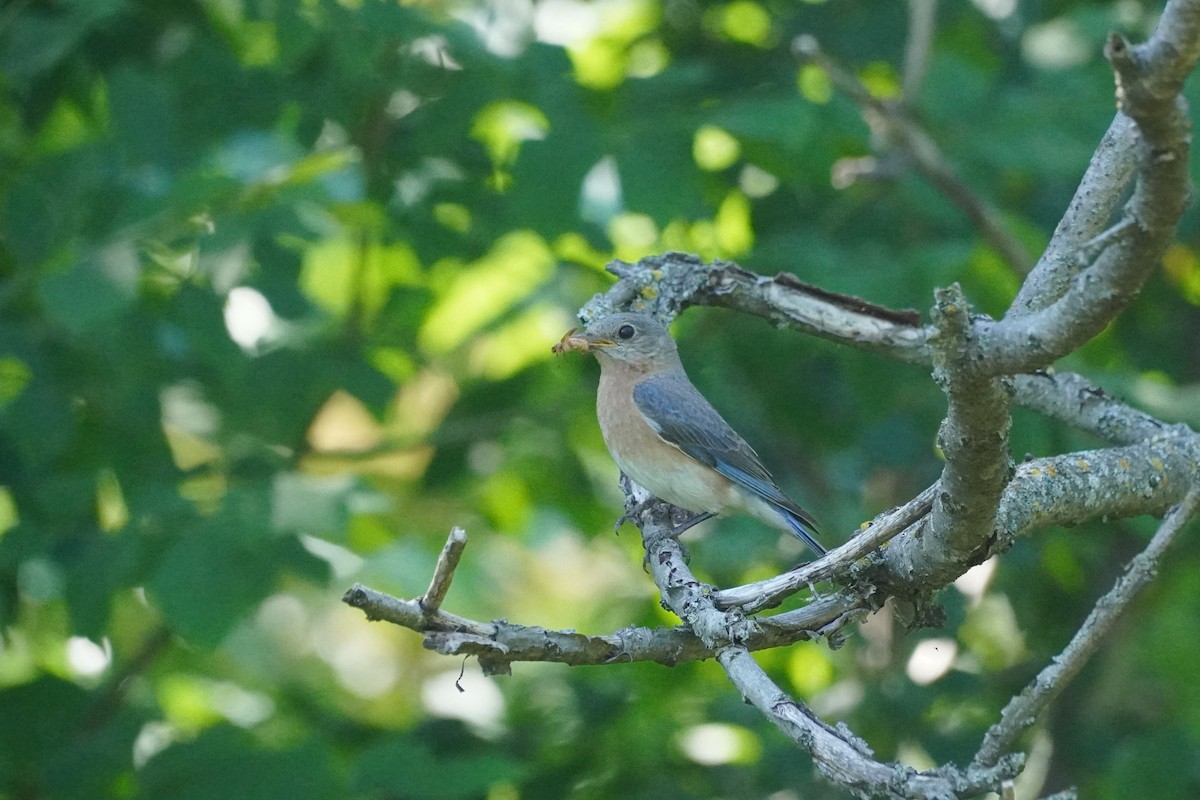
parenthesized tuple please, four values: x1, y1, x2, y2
(634, 372, 816, 527)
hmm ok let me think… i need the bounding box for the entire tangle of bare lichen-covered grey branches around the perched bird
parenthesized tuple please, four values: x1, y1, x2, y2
(344, 0, 1200, 800)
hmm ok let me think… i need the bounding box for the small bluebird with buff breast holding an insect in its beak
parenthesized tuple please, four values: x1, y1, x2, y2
(553, 313, 826, 555)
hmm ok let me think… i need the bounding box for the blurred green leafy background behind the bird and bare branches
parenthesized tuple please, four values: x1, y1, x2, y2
(0, 0, 1200, 800)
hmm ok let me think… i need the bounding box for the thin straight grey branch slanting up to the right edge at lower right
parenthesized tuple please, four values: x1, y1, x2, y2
(974, 488, 1200, 766)
